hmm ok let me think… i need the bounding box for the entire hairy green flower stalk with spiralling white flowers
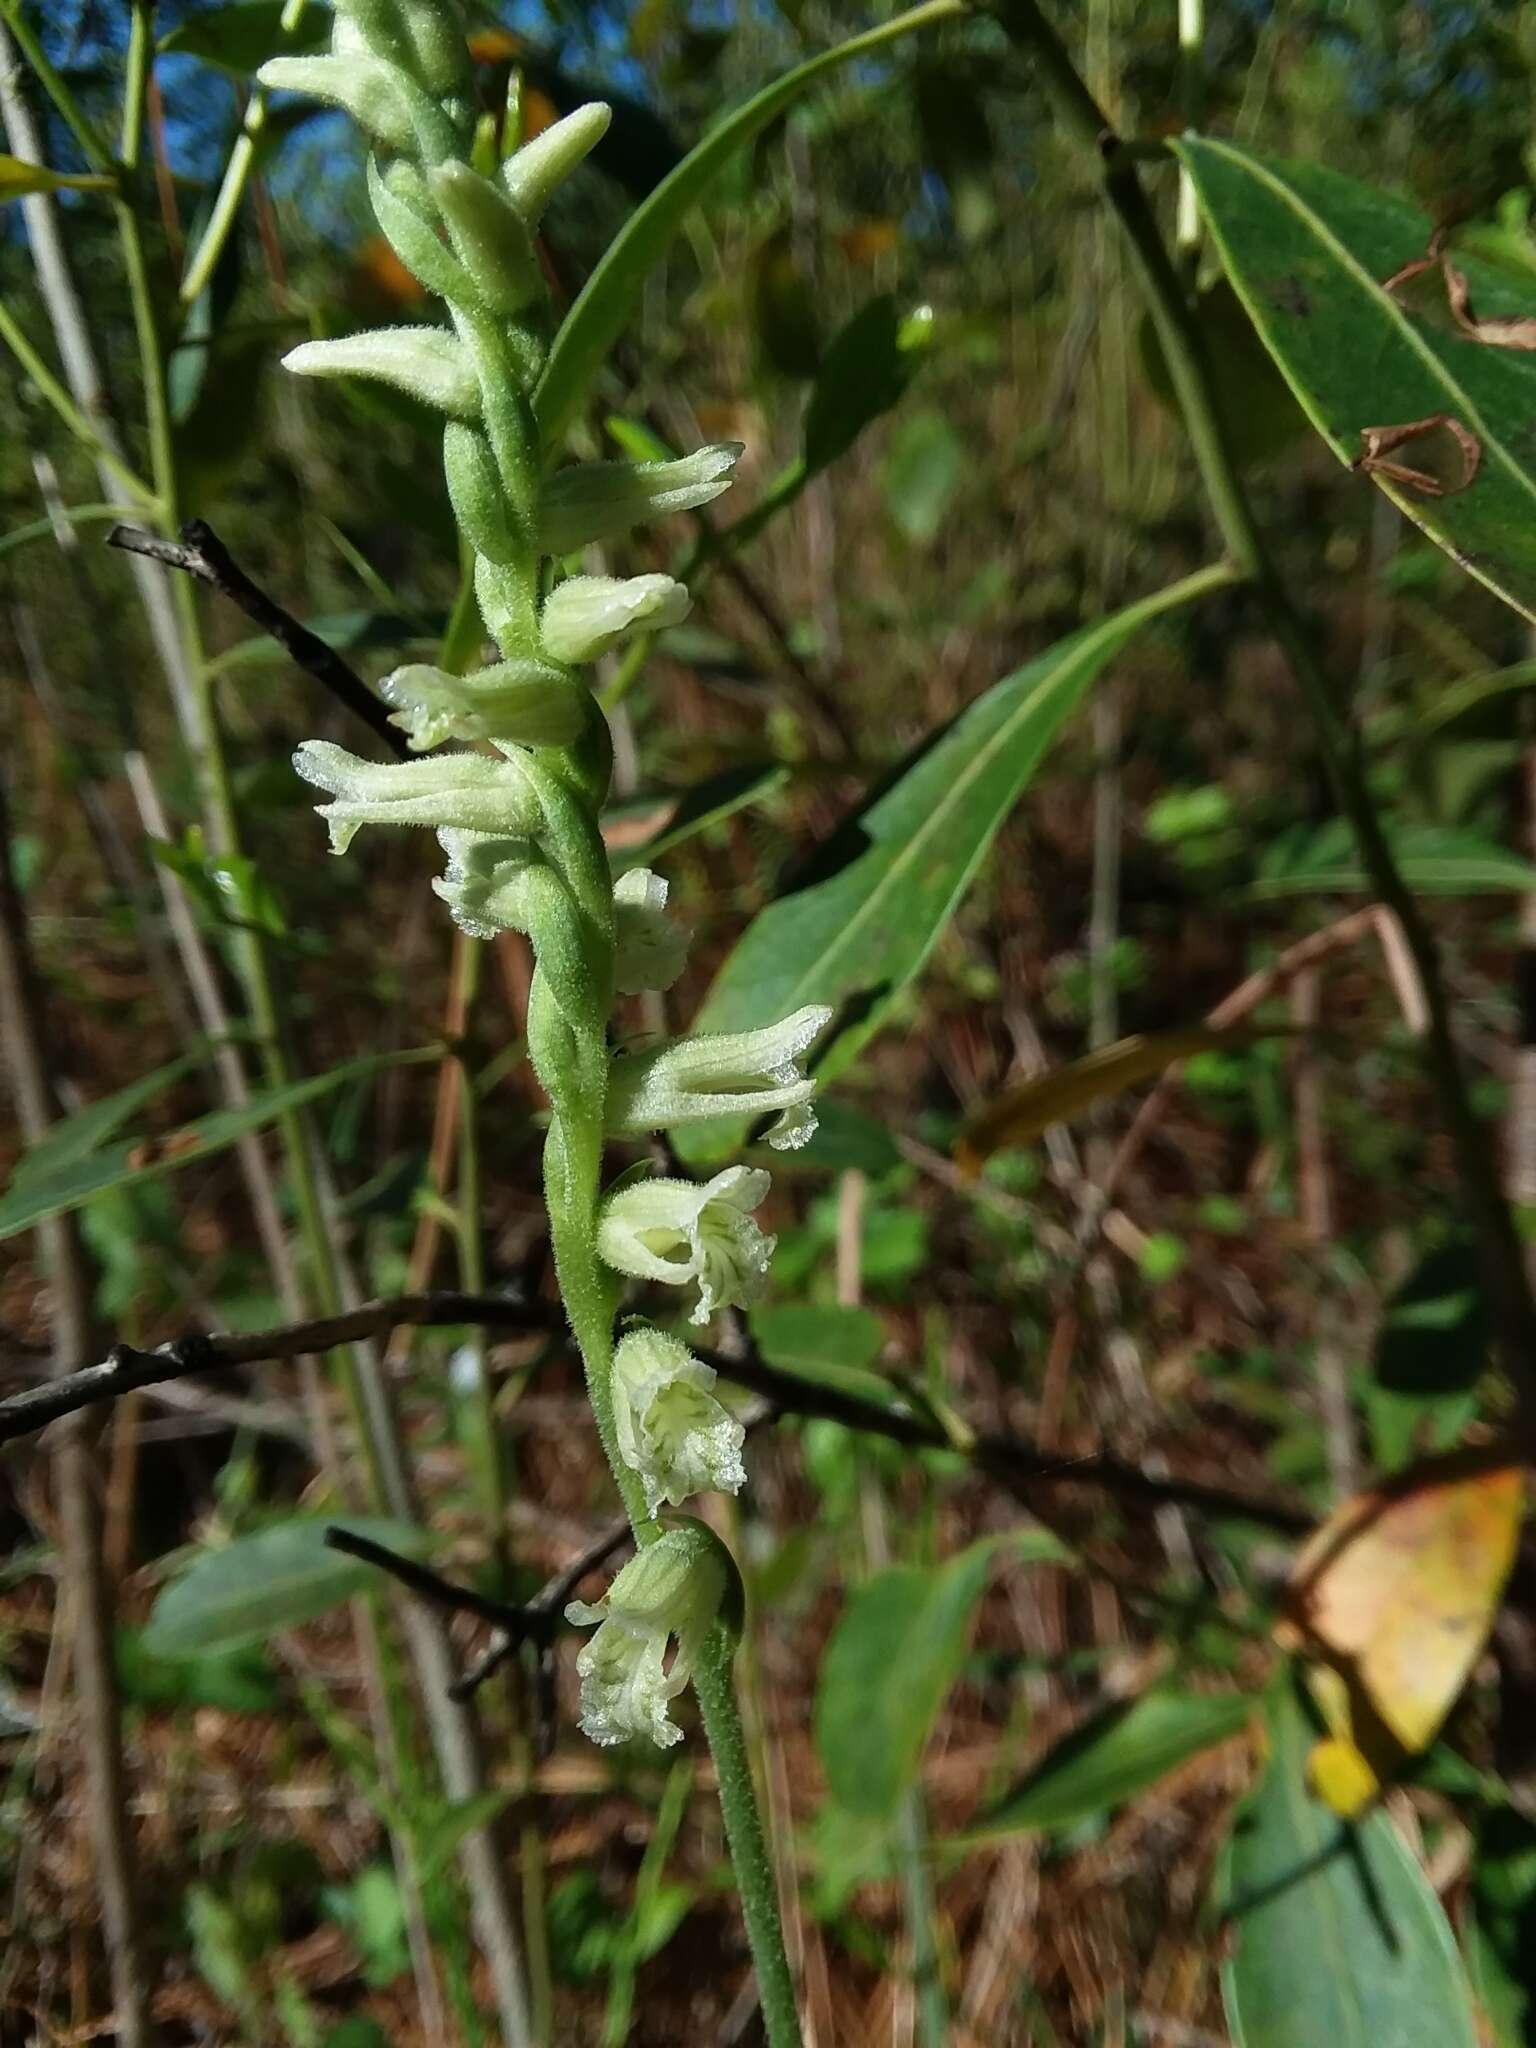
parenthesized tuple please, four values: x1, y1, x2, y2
(274, 0, 827, 2048)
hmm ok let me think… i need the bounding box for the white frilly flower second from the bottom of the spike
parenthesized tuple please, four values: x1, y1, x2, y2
(612, 1325, 748, 1513)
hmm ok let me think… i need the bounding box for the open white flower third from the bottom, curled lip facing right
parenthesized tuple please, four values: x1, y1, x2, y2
(598, 1165, 774, 1323)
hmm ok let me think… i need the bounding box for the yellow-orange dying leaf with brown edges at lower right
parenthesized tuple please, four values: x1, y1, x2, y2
(1276, 1450, 1526, 1815)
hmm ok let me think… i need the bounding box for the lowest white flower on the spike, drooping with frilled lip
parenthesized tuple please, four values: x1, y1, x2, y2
(565, 1522, 731, 1749)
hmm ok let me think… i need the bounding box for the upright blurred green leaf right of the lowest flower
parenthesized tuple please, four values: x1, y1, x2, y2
(815, 1540, 997, 1815)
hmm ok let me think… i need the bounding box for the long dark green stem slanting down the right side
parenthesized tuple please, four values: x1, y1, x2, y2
(995, 0, 1536, 1425)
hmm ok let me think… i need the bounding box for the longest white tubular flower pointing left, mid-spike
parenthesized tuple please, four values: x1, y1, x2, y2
(293, 739, 543, 854)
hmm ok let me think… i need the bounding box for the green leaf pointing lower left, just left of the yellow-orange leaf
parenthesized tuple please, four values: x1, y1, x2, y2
(961, 1686, 1253, 1841)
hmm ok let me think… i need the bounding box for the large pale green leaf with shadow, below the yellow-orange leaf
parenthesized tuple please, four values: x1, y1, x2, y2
(1221, 1688, 1477, 2048)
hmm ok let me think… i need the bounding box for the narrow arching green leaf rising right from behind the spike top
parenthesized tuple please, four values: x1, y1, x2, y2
(535, 0, 965, 451)
